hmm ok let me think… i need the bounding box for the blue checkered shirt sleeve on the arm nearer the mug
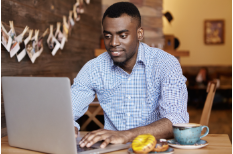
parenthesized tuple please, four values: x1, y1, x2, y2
(159, 57, 189, 124)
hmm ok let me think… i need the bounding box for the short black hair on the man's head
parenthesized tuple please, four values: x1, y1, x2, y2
(102, 2, 141, 27)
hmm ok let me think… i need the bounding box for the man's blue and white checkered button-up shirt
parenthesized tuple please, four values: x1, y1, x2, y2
(71, 43, 189, 130)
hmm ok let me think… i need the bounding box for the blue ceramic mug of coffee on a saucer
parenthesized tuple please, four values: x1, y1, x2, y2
(172, 123, 209, 145)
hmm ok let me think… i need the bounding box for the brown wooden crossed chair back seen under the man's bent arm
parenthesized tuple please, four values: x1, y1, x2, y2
(80, 101, 104, 131)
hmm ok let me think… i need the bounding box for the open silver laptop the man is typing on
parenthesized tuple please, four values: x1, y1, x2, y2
(2, 77, 129, 154)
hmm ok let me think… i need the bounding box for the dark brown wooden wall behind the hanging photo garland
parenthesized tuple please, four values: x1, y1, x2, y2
(1, 0, 102, 134)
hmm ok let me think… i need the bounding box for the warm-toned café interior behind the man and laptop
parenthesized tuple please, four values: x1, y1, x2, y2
(1, 0, 232, 153)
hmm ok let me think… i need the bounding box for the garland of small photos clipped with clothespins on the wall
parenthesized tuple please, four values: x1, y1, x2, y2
(1, 0, 90, 63)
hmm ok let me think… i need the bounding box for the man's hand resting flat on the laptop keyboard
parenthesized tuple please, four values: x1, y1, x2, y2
(79, 129, 130, 148)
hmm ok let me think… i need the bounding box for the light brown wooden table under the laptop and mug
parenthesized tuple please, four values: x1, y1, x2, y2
(1, 132, 232, 154)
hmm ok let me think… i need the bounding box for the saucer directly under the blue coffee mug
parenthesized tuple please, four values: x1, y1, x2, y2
(167, 139, 208, 149)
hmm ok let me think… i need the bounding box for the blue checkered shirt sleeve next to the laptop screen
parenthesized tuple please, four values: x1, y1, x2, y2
(71, 63, 95, 130)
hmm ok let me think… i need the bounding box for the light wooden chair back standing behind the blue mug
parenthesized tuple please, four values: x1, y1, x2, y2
(200, 81, 217, 126)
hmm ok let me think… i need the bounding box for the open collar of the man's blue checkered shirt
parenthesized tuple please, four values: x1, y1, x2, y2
(109, 42, 146, 68)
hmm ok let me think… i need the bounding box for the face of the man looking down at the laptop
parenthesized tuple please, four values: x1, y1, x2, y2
(103, 14, 143, 67)
